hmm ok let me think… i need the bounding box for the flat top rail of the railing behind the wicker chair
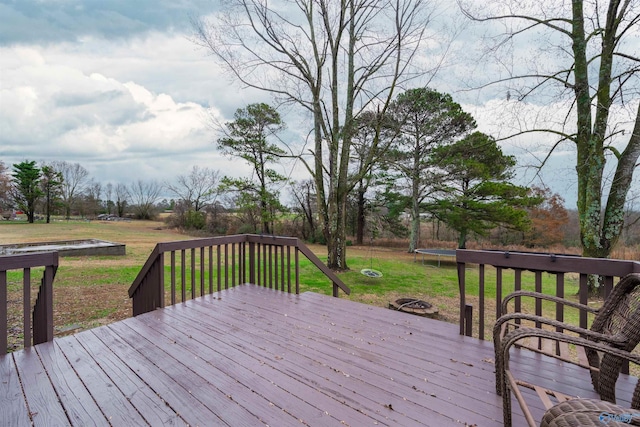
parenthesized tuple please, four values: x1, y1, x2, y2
(456, 249, 640, 277)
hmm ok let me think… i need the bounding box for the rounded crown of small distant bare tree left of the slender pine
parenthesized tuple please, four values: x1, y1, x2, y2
(165, 166, 220, 212)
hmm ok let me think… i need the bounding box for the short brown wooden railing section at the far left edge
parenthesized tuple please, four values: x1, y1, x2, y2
(0, 252, 58, 351)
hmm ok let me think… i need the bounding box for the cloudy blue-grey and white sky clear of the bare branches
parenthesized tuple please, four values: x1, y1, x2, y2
(0, 0, 632, 207)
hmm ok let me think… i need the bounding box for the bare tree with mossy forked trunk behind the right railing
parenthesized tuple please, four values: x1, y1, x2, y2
(462, 0, 640, 264)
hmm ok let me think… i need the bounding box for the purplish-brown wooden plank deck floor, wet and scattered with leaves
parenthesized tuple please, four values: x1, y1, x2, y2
(0, 285, 626, 426)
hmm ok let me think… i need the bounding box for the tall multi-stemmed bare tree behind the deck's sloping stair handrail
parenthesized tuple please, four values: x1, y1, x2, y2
(194, 0, 442, 270)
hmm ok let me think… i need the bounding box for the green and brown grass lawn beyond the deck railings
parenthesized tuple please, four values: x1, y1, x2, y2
(0, 221, 592, 350)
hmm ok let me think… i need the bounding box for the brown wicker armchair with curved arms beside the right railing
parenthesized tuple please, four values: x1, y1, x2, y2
(494, 273, 640, 426)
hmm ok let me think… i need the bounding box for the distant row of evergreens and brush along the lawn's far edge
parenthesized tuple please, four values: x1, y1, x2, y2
(0, 88, 576, 251)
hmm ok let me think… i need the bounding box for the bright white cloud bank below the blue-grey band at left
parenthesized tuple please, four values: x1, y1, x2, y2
(0, 39, 262, 189)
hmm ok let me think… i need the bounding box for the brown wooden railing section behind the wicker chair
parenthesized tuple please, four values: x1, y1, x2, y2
(456, 249, 640, 339)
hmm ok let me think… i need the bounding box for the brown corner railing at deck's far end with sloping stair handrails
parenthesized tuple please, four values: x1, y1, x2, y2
(129, 234, 350, 316)
